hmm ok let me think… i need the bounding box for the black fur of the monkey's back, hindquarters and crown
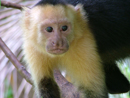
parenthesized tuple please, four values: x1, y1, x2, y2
(37, 0, 130, 93)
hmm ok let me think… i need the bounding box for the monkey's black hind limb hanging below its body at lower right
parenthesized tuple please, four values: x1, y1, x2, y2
(104, 63, 129, 94)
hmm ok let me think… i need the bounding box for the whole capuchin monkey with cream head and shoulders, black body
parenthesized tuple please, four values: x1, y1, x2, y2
(22, 0, 130, 98)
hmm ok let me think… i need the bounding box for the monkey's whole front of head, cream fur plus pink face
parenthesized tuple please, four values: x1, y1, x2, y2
(25, 5, 76, 55)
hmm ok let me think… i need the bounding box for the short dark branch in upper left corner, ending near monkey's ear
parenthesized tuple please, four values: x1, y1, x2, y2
(1, 1, 24, 10)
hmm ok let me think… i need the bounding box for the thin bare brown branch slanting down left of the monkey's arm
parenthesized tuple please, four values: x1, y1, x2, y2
(0, 38, 33, 84)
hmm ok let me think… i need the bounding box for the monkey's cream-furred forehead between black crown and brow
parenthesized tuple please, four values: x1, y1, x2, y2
(31, 5, 74, 21)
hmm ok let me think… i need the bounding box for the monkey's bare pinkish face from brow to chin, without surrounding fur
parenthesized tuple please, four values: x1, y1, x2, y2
(39, 19, 71, 55)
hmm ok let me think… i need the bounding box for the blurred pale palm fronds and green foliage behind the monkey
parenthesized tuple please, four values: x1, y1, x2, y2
(0, 0, 130, 98)
